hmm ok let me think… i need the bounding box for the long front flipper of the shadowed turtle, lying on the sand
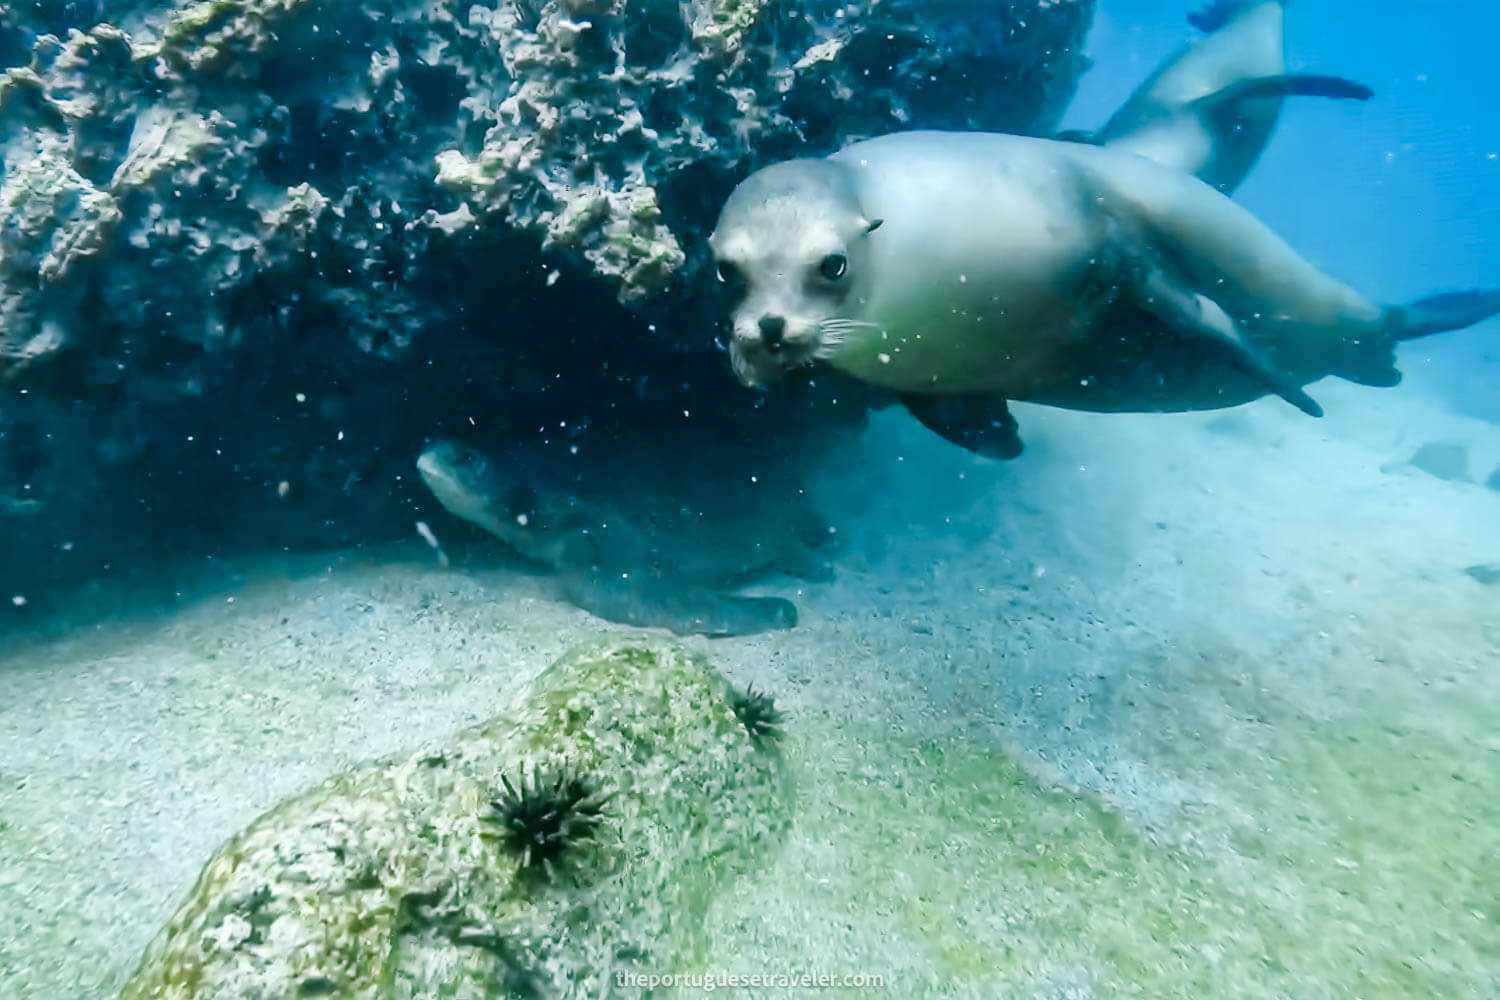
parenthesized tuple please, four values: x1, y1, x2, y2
(560, 571, 797, 637)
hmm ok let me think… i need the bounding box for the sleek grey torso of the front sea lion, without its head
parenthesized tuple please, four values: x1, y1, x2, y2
(833, 132, 1382, 411)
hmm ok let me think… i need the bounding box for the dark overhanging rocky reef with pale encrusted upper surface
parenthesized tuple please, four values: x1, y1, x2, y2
(0, 0, 1094, 594)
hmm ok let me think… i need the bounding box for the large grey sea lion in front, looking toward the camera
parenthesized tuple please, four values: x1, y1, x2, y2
(710, 132, 1500, 415)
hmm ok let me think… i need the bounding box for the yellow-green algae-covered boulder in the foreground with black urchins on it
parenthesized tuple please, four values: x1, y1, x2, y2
(122, 639, 789, 1000)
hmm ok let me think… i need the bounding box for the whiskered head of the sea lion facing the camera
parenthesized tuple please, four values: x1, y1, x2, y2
(708, 159, 881, 387)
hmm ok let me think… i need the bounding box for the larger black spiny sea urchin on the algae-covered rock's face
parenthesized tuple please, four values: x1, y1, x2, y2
(489, 766, 609, 876)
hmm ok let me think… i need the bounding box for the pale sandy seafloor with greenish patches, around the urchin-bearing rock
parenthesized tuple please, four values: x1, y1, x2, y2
(0, 382, 1500, 1000)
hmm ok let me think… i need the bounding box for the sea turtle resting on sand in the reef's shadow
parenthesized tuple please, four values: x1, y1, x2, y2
(417, 441, 831, 636)
